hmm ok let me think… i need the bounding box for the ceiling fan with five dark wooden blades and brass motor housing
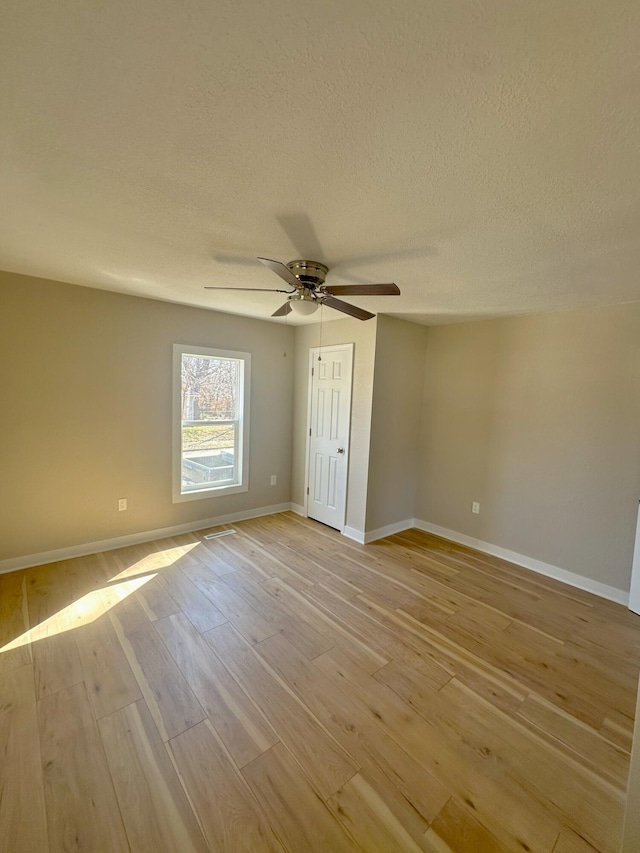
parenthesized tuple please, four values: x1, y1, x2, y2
(205, 258, 400, 320)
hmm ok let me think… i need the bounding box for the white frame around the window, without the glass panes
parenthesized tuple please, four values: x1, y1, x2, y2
(172, 344, 251, 503)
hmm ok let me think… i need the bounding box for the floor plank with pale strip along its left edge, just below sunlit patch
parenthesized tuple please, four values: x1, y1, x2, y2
(109, 611, 206, 741)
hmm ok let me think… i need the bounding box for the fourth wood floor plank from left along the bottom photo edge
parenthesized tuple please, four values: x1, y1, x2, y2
(169, 720, 283, 853)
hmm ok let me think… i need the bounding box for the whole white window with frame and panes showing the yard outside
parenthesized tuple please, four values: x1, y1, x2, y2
(173, 344, 251, 502)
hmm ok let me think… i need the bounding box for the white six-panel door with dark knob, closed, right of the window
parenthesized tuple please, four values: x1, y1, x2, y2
(307, 344, 353, 530)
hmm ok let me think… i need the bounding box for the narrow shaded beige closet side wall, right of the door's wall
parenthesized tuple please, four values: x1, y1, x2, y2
(366, 315, 428, 531)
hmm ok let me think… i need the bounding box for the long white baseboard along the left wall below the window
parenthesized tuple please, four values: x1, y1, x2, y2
(0, 503, 295, 574)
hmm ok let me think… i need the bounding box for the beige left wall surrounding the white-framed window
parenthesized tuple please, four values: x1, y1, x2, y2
(0, 273, 293, 559)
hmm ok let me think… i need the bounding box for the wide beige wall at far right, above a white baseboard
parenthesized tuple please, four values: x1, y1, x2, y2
(416, 303, 640, 590)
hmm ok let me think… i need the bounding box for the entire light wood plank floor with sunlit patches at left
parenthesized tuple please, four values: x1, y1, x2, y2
(0, 513, 640, 853)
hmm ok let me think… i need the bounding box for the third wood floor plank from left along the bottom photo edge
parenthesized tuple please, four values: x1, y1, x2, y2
(99, 700, 209, 853)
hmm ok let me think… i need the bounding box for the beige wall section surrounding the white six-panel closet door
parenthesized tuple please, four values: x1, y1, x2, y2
(291, 318, 377, 531)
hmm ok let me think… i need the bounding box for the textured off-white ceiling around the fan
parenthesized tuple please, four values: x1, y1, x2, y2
(0, 0, 640, 323)
